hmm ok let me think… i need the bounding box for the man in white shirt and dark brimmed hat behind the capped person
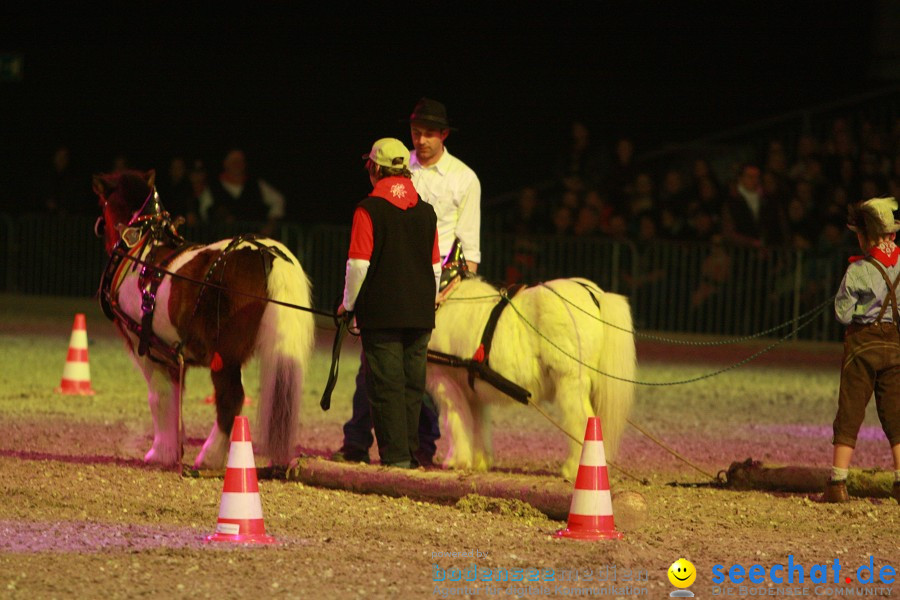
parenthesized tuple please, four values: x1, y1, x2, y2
(332, 98, 481, 467)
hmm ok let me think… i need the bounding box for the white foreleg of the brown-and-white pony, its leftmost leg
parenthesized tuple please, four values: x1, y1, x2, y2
(138, 357, 184, 467)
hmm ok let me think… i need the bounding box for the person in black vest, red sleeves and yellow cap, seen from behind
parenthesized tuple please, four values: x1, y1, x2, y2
(338, 138, 441, 469)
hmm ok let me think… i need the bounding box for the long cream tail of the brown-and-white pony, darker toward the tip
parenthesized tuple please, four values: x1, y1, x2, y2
(256, 246, 315, 466)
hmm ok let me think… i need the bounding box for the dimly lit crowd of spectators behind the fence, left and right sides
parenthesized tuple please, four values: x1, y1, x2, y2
(30, 112, 900, 258)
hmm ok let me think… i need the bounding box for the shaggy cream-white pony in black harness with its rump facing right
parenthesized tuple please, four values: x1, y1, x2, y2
(427, 277, 636, 479)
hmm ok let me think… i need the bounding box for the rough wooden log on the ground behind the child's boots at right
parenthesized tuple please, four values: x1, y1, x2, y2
(726, 458, 893, 498)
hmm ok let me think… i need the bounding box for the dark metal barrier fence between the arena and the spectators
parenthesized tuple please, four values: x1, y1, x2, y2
(0, 215, 847, 340)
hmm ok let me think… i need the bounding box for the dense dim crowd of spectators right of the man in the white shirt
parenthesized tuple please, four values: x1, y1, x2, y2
(486, 118, 900, 255)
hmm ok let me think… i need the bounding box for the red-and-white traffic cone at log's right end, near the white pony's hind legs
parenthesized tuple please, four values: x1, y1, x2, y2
(556, 417, 622, 540)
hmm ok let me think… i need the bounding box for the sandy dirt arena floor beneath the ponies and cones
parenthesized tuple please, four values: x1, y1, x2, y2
(0, 296, 900, 599)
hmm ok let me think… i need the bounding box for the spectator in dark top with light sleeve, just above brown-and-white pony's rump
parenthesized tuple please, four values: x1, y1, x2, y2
(210, 149, 285, 235)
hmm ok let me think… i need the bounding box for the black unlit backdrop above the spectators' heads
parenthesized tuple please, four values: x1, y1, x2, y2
(0, 1, 884, 222)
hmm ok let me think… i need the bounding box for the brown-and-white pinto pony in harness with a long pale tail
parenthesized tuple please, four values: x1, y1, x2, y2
(93, 171, 314, 469)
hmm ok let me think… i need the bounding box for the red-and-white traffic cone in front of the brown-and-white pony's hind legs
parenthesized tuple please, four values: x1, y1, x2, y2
(206, 416, 277, 544)
